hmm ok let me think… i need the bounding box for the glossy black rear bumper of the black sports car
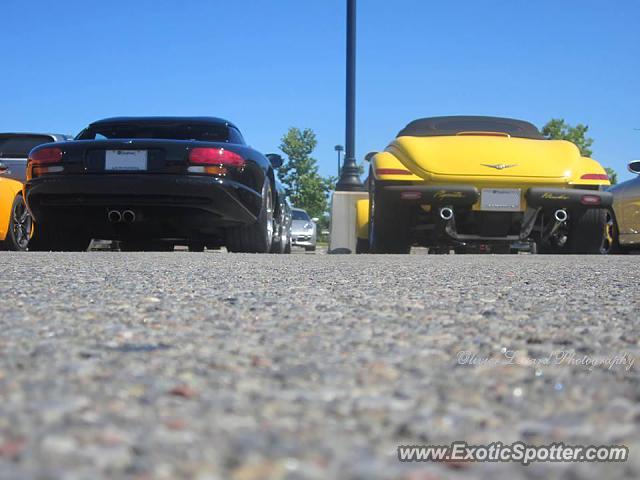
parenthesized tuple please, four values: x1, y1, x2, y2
(25, 174, 262, 225)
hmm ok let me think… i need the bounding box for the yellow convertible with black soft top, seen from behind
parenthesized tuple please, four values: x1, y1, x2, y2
(357, 116, 613, 254)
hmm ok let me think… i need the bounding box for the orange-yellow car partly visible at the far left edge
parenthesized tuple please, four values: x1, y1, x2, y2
(0, 162, 33, 251)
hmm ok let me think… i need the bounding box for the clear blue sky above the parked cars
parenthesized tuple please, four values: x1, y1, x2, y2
(0, 0, 640, 179)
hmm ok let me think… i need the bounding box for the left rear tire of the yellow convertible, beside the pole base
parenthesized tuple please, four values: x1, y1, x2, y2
(369, 174, 411, 254)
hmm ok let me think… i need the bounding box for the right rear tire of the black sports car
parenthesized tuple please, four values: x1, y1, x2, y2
(226, 178, 274, 253)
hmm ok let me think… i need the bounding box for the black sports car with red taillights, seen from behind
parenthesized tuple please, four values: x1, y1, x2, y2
(25, 117, 291, 253)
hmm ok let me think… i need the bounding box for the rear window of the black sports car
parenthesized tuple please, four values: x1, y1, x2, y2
(77, 124, 229, 142)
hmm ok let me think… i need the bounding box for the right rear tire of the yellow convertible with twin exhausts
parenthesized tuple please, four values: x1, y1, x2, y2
(567, 208, 609, 255)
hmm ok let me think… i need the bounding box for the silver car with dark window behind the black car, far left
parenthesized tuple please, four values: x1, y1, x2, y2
(0, 133, 73, 183)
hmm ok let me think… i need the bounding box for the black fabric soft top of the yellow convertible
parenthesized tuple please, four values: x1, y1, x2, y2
(398, 116, 544, 140)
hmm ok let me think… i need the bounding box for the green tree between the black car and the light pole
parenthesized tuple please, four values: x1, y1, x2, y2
(278, 127, 335, 217)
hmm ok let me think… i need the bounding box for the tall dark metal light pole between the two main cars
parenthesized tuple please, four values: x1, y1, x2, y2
(336, 0, 364, 192)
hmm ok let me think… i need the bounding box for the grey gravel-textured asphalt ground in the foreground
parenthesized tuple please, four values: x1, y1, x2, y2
(0, 252, 640, 480)
